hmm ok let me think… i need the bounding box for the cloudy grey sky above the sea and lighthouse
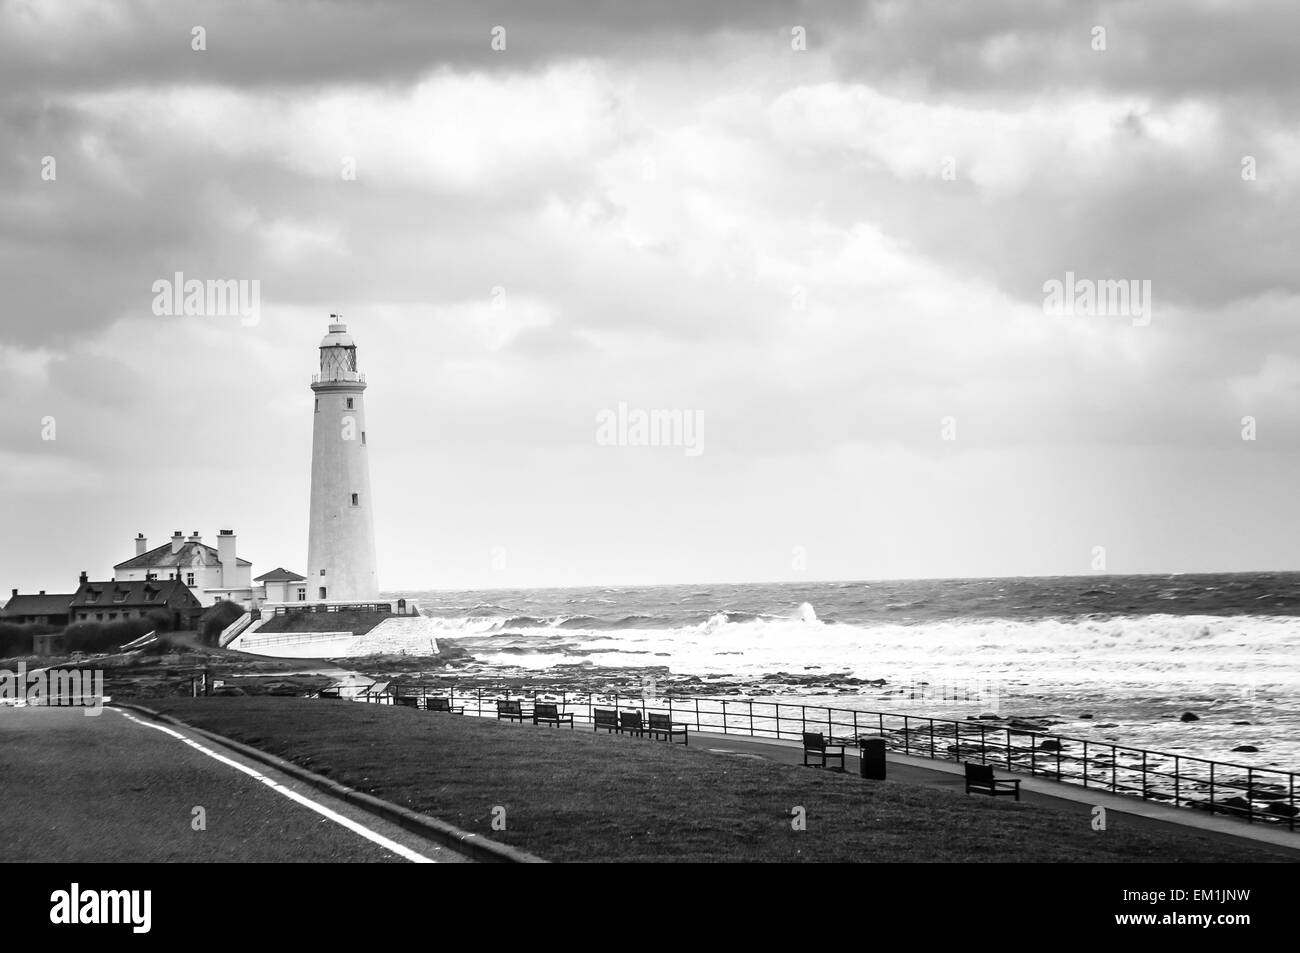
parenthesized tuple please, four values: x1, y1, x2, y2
(0, 0, 1300, 592)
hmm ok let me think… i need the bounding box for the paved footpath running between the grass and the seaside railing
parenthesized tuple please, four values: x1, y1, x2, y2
(690, 732, 1300, 859)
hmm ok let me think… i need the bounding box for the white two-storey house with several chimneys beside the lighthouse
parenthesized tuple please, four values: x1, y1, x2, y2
(113, 529, 254, 608)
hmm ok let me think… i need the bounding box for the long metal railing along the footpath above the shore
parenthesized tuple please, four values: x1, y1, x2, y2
(358, 683, 1300, 831)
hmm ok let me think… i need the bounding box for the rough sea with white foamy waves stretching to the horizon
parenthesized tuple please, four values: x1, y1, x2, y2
(390, 572, 1300, 771)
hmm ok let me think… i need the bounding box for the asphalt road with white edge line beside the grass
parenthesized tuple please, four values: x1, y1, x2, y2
(0, 707, 465, 863)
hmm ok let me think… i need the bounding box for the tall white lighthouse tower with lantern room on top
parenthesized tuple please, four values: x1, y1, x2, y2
(307, 315, 380, 602)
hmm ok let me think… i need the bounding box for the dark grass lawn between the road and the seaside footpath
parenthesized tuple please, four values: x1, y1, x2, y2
(150, 697, 1291, 862)
